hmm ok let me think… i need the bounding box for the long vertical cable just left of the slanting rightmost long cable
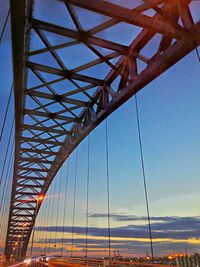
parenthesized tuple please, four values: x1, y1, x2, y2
(106, 118, 111, 258)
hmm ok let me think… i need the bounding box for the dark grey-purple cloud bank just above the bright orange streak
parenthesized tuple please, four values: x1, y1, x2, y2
(36, 214, 200, 240)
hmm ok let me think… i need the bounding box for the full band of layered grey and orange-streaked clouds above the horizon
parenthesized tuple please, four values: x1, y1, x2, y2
(33, 214, 200, 255)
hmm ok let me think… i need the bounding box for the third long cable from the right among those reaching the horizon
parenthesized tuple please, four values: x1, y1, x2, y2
(85, 135, 90, 258)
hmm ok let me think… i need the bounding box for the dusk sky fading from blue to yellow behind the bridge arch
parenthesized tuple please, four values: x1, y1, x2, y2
(0, 0, 200, 260)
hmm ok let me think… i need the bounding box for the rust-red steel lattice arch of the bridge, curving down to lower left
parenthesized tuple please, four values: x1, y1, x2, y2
(5, 0, 200, 259)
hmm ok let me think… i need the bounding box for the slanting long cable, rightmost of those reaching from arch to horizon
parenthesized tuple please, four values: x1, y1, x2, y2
(135, 94, 154, 261)
